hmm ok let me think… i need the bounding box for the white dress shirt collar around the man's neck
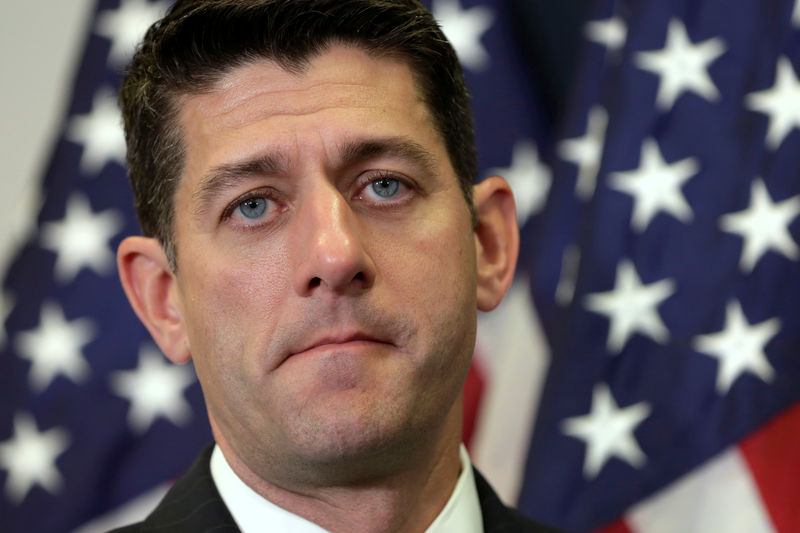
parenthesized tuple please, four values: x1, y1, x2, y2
(210, 445, 483, 533)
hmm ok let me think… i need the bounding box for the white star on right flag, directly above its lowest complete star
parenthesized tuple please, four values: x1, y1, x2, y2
(584, 259, 675, 354)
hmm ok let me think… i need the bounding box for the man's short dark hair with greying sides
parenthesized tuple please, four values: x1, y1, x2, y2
(119, 0, 477, 270)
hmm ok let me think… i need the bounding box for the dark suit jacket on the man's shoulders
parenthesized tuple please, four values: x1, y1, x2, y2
(111, 446, 556, 533)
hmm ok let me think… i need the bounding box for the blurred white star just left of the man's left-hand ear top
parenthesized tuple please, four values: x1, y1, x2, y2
(41, 193, 123, 284)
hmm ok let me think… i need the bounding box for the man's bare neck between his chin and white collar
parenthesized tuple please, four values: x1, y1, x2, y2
(212, 399, 462, 533)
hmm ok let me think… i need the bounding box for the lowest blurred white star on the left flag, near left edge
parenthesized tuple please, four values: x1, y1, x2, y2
(0, 413, 69, 505)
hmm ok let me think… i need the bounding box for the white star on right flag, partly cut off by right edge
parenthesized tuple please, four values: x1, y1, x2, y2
(745, 56, 800, 150)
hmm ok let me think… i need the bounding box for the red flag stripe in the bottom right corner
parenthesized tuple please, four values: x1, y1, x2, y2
(740, 403, 800, 533)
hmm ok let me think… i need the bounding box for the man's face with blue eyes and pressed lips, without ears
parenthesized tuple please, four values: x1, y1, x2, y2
(174, 46, 476, 484)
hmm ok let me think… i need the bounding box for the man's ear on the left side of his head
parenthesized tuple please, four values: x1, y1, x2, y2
(117, 237, 191, 363)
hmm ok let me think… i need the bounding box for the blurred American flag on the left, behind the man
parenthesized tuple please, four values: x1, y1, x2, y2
(0, 0, 211, 533)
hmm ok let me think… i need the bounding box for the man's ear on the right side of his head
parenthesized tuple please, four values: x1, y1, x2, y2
(473, 176, 519, 311)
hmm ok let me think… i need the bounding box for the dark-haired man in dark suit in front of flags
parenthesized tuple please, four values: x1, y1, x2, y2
(112, 0, 560, 532)
